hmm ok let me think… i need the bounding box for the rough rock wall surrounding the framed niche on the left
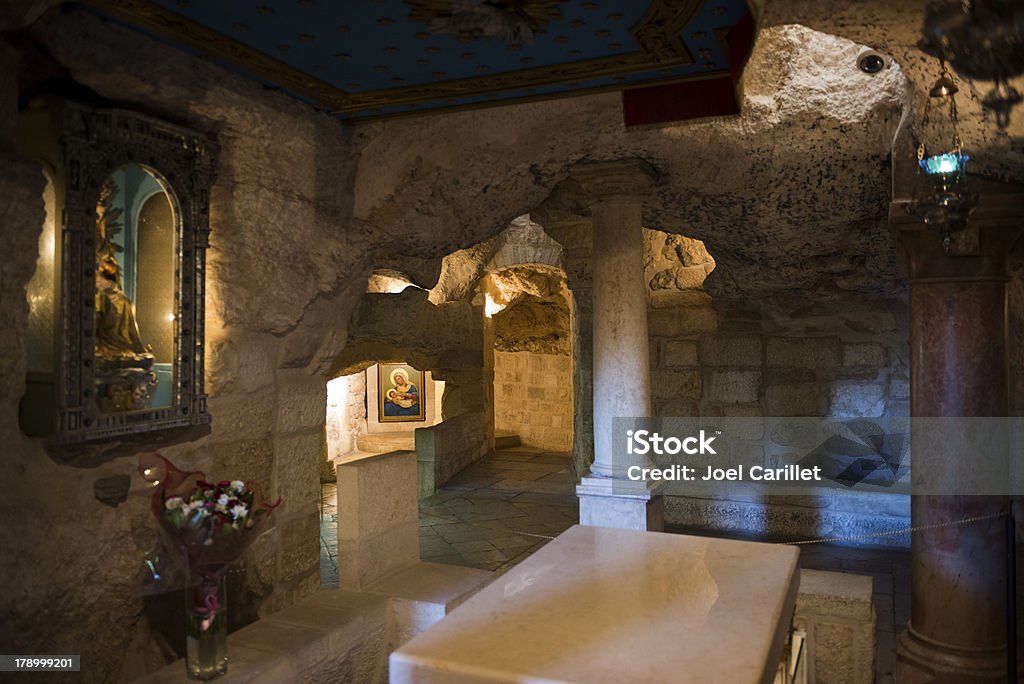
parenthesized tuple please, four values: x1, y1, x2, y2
(0, 3, 370, 682)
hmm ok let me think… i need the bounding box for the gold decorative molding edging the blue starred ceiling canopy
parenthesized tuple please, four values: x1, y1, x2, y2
(85, 0, 727, 119)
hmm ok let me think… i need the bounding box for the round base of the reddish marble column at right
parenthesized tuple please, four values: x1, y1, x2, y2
(895, 625, 1007, 684)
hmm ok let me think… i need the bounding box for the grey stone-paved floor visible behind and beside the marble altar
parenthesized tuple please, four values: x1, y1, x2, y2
(321, 447, 910, 684)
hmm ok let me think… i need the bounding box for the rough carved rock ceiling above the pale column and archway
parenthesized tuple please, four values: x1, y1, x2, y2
(355, 26, 921, 297)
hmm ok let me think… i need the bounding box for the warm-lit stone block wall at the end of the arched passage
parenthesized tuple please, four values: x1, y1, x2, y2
(495, 351, 572, 452)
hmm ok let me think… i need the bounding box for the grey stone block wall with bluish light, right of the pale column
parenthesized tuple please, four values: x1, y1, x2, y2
(648, 292, 909, 547)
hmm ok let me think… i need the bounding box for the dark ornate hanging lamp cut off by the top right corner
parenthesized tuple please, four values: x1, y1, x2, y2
(921, 0, 1024, 128)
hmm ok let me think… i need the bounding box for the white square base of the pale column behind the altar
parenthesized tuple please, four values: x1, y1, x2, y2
(577, 475, 665, 531)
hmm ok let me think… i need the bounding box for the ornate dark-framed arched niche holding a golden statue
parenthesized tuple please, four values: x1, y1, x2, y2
(18, 97, 216, 444)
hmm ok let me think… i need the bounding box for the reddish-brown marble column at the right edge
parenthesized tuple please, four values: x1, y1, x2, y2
(890, 188, 1024, 684)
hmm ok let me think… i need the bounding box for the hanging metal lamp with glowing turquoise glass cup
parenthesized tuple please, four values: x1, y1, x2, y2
(910, 61, 978, 252)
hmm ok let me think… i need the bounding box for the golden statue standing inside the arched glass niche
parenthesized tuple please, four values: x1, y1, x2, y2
(95, 179, 158, 413)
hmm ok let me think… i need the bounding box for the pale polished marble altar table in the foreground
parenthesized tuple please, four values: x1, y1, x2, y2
(390, 525, 799, 684)
